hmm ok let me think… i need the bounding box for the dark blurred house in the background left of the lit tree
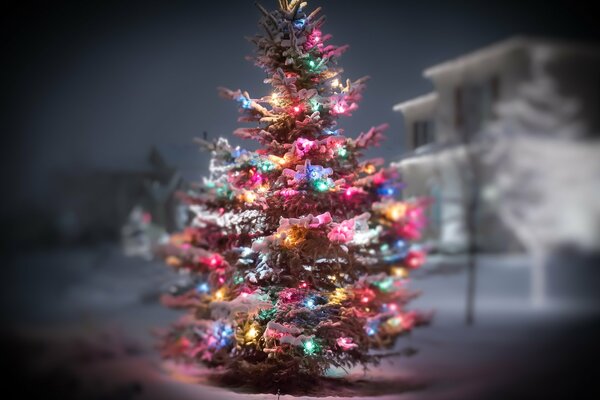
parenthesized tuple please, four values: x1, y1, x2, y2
(57, 148, 185, 241)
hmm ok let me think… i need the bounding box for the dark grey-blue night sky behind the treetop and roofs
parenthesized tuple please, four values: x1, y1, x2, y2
(0, 0, 598, 212)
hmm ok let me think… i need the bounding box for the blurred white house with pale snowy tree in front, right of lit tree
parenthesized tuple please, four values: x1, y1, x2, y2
(394, 37, 600, 304)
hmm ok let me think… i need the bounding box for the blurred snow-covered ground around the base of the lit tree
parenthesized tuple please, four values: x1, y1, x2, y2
(1, 245, 600, 400)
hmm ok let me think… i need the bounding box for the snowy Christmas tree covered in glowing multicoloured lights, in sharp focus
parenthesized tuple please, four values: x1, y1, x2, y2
(163, 0, 426, 387)
